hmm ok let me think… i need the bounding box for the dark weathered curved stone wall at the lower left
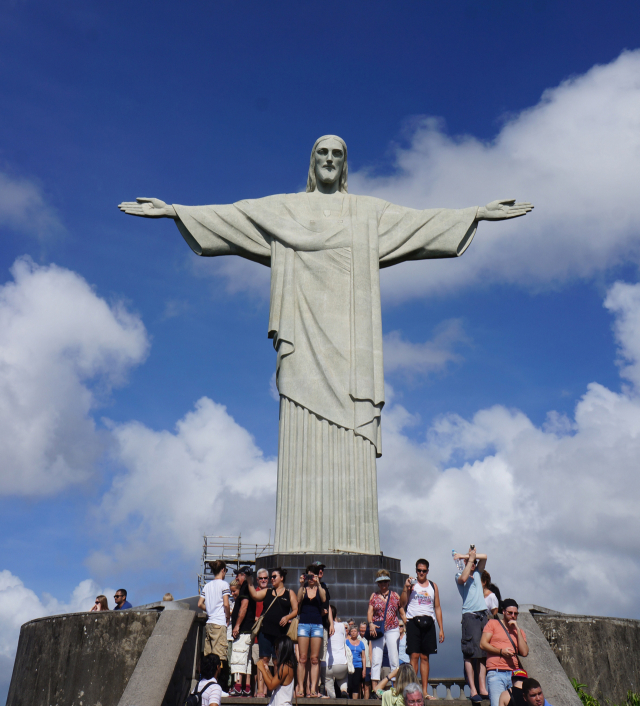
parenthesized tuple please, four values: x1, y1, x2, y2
(7, 610, 160, 706)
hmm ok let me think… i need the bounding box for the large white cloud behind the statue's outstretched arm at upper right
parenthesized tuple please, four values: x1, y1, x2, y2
(349, 50, 640, 299)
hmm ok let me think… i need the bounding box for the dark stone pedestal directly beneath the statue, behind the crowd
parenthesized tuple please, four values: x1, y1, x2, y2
(256, 553, 407, 620)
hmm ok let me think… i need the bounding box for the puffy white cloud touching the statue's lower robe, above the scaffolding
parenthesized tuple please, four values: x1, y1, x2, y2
(88, 397, 276, 574)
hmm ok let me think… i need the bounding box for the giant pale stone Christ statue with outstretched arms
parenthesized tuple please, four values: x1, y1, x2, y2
(119, 135, 533, 554)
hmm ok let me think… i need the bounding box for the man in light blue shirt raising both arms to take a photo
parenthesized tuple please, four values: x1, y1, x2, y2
(454, 544, 489, 703)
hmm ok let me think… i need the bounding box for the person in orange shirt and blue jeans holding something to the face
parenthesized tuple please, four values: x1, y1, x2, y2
(480, 598, 529, 706)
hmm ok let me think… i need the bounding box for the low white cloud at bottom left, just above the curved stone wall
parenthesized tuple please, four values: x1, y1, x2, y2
(0, 569, 114, 692)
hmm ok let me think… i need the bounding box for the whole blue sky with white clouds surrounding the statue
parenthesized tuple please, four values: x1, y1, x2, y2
(0, 1, 640, 684)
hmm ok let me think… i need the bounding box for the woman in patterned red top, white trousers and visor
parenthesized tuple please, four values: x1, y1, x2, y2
(367, 569, 400, 691)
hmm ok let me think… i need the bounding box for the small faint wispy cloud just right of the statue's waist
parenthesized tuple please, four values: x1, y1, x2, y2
(384, 319, 469, 375)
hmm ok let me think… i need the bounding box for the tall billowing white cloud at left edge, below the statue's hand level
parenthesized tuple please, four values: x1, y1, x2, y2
(0, 258, 148, 495)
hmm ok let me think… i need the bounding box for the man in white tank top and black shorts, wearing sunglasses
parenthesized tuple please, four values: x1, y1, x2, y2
(400, 559, 444, 700)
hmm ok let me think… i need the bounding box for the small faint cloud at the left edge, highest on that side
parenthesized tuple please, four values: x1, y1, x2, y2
(0, 172, 62, 237)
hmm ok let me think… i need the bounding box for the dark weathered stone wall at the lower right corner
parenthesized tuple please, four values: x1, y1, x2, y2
(533, 613, 640, 704)
